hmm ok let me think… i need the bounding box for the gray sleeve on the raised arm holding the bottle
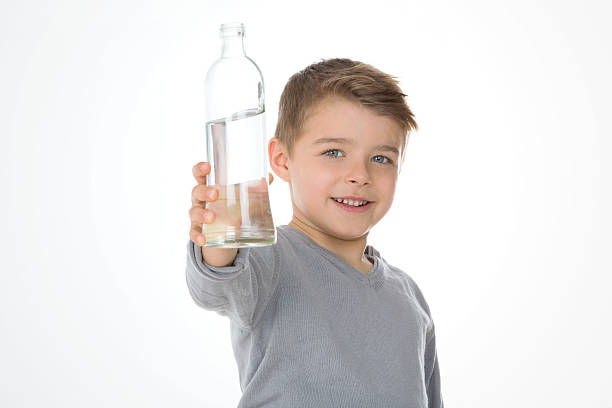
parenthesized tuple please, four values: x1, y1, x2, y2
(186, 240, 279, 329)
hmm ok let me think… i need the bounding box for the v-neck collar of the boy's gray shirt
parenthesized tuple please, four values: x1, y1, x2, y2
(278, 224, 383, 287)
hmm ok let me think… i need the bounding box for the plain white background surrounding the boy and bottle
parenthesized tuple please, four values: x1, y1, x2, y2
(0, 0, 612, 408)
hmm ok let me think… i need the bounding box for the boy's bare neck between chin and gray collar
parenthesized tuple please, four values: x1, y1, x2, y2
(289, 214, 372, 274)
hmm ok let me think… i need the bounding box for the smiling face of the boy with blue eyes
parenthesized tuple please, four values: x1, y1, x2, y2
(272, 97, 402, 240)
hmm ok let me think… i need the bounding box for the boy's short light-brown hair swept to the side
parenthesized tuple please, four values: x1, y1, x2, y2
(274, 58, 418, 163)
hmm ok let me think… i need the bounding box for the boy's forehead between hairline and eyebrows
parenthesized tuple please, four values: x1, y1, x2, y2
(300, 97, 402, 149)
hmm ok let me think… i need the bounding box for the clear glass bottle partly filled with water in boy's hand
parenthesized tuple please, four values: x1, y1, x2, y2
(202, 22, 276, 248)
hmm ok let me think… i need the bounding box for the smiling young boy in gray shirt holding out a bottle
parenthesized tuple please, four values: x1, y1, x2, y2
(186, 59, 444, 408)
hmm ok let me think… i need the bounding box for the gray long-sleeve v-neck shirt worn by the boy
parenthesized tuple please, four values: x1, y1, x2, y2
(186, 225, 444, 408)
